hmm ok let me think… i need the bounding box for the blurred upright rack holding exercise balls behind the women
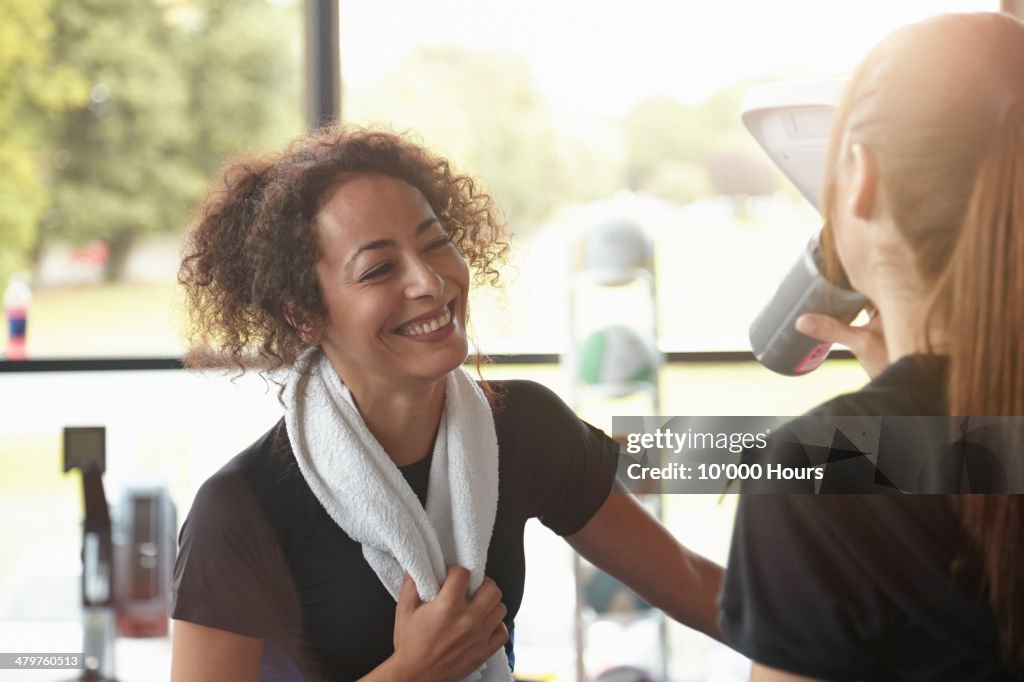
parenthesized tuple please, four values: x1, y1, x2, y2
(562, 214, 668, 680)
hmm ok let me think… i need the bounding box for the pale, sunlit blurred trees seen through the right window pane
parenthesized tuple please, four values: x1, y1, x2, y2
(354, 46, 798, 231)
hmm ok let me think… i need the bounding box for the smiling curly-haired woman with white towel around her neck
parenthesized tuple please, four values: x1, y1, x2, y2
(172, 128, 721, 682)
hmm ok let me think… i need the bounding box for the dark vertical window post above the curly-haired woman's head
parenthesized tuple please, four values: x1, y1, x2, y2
(305, 0, 341, 129)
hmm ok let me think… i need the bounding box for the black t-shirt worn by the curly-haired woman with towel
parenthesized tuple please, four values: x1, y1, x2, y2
(172, 381, 618, 682)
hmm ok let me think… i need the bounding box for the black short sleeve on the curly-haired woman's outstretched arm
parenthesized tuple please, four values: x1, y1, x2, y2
(496, 381, 618, 536)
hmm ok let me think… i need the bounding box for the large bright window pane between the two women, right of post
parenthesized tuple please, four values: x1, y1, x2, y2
(341, 0, 998, 352)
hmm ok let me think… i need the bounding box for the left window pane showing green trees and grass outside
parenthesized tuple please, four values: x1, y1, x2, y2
(0, 0, 302, 357)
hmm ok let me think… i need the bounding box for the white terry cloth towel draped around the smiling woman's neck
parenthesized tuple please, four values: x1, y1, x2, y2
(284, 348, 512, 682)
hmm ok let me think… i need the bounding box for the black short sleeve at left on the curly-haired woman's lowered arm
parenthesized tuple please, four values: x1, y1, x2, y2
(171, 468, 287, 638)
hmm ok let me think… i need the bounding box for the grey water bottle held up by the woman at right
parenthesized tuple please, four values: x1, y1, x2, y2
(750, 235, 867, 377)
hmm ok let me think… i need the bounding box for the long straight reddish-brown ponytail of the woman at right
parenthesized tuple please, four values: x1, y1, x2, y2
(935, 99, 1024, 664)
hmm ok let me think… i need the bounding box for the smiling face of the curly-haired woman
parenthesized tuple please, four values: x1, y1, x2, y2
(315, 175, 469, 425)
